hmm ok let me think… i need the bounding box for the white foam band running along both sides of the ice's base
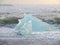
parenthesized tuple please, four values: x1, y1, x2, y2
(0, 27, 60, 39)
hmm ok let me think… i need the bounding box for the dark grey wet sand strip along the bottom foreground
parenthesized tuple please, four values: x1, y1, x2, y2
(0, 38, 60, 45)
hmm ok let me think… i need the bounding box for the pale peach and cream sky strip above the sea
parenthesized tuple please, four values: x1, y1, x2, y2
(0, 0, 60, 5)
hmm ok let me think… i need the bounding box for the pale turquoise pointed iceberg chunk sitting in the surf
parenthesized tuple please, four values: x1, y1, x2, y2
(15, 14, 56, 34)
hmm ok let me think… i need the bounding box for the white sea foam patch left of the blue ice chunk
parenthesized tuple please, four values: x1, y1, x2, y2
(0, 27, 15, 36)
